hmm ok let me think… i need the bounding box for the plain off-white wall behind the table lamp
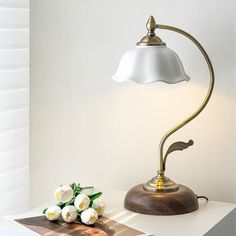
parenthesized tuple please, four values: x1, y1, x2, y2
(30, 0, 236, 206)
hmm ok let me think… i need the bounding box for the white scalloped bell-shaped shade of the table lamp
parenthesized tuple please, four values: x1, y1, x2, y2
(112, 46, 190, 84)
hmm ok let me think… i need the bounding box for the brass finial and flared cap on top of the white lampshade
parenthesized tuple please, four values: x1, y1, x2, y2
(137, 16, 166, 46)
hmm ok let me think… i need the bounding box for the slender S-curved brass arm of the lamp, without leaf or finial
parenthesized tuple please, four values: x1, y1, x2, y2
(156, 24, 215, 175)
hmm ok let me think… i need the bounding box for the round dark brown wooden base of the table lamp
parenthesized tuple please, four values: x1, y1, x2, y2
(124, 184, 198, 215)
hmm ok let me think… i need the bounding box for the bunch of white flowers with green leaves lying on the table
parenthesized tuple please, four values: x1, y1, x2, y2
(43, 183, 105, 225)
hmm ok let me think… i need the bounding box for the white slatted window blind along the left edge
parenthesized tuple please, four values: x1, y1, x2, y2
(0, 0, 29, 216)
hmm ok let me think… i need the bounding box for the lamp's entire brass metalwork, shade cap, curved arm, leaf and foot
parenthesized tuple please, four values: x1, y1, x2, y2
(137, 16, 215, 192)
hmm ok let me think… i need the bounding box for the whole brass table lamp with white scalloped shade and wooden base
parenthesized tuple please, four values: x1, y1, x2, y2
(112, 16, 215, 215)
